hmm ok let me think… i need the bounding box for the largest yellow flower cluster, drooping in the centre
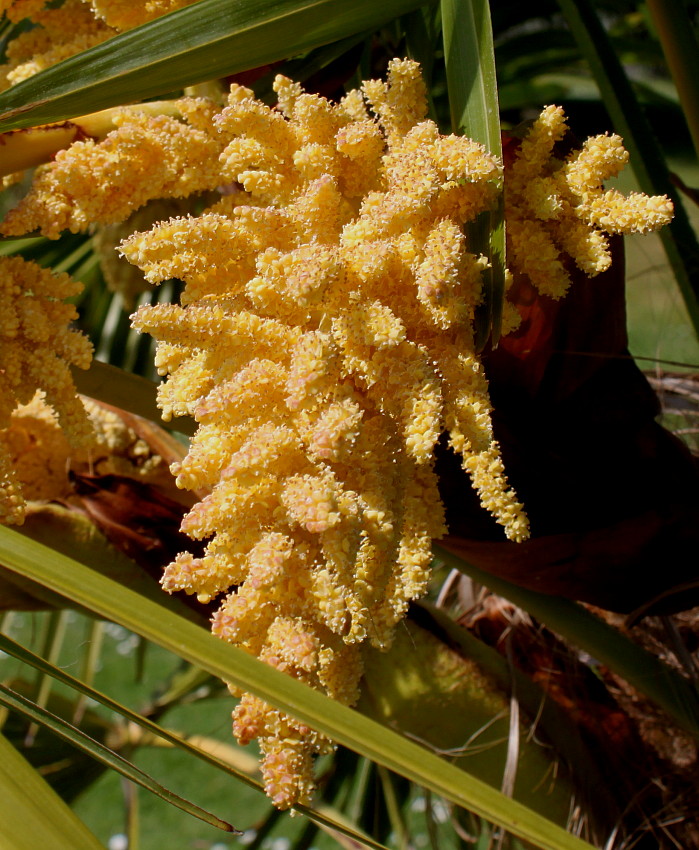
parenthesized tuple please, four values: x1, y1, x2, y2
(116, 60, 528, 807)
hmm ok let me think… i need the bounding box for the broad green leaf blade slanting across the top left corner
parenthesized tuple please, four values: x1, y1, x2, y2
(0, 0, 422, 131)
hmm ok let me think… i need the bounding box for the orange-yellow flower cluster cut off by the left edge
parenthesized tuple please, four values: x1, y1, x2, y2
(0, 257, 92, 523)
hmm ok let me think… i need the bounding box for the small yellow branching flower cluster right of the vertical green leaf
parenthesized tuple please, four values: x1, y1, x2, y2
(505, 106, 673, 298)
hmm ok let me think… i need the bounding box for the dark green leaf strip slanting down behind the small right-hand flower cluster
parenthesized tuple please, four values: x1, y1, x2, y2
(558, 0, 699, 338)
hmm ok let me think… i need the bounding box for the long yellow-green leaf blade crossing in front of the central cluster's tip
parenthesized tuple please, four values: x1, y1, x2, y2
(0, 528, 590, 850)
